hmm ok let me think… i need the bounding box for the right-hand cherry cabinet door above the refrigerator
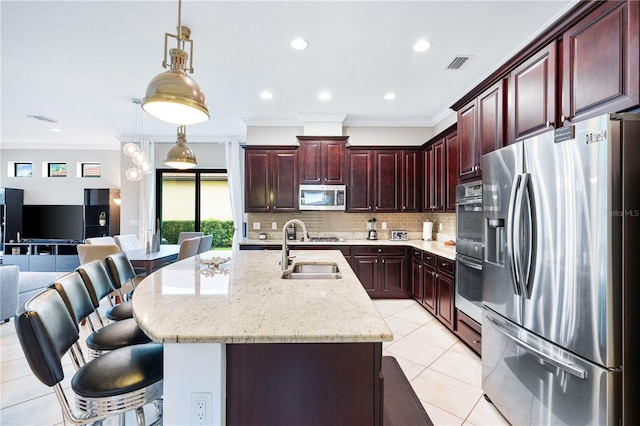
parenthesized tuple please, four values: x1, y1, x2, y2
(560, 1, 640, 124)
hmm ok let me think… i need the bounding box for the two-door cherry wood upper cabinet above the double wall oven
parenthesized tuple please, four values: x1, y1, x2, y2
(458, 80, 506, 180)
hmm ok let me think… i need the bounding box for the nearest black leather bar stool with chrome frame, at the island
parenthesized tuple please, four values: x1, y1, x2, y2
(15, 289, 163, 426)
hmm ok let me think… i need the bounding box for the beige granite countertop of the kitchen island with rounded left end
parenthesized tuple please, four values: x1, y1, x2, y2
(133, 250, 393, 343)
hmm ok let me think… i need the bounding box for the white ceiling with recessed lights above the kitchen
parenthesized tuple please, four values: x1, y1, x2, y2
(0, 0, 575, 149)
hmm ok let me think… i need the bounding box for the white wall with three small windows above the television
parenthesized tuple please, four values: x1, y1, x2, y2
(0, 149, 120, 204)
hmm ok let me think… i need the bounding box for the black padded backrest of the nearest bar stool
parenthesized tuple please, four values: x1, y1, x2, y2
(15, 289, 79, 387)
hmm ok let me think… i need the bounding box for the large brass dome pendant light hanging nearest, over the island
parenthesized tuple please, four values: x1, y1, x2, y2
(142, 0, 209, 125)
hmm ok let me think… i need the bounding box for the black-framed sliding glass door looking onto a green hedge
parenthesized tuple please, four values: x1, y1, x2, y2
(156, 169, 234, 247)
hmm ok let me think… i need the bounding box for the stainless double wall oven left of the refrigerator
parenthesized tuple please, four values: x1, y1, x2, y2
(455, 181, 483, 323)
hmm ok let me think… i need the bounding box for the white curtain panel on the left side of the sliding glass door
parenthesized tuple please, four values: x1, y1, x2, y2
(138, 139, 156, 247)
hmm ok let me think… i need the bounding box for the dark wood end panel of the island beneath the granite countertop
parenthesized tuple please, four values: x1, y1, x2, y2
(226, 343, 382, 426)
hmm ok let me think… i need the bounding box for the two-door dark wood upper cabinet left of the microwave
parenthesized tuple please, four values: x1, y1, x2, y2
(244, 147, 298, 213)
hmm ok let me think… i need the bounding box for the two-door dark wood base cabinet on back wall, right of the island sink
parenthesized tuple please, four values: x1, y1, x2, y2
(351, 246, 409, 298)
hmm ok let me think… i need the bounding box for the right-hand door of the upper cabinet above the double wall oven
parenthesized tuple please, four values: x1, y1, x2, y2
(476, 80, 505, 158)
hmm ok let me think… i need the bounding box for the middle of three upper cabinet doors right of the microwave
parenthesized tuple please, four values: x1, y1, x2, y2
(373, 150, 402, 212)
